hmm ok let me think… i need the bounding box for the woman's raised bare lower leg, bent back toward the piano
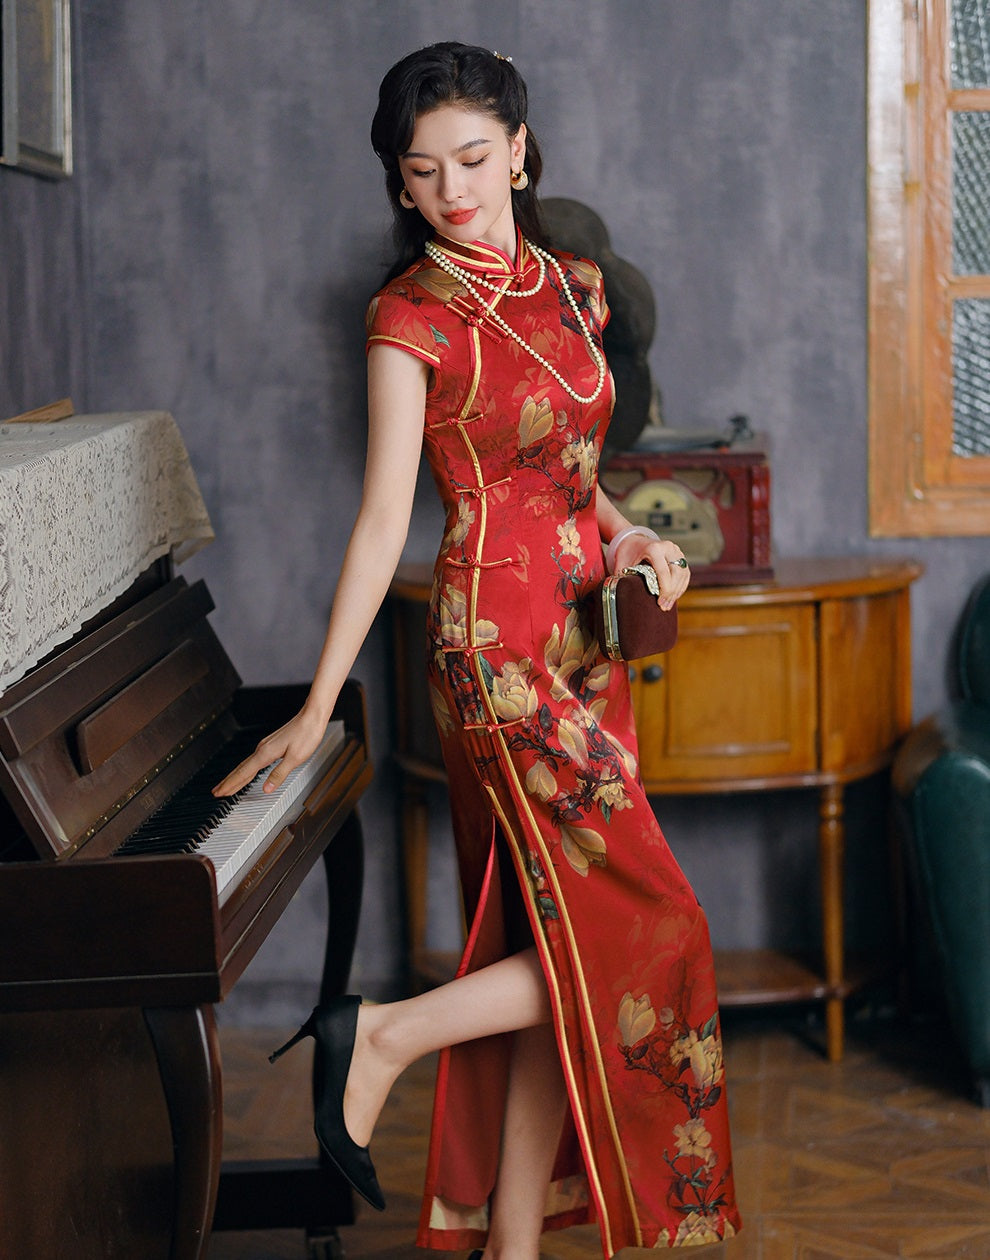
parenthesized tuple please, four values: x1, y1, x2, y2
(344, 949, 546, 1158)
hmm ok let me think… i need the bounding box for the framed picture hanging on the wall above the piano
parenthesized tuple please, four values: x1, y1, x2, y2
(0, 0, 72, 176)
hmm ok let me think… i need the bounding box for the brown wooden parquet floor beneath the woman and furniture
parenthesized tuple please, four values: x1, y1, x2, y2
(208, 1013, 990, 1260)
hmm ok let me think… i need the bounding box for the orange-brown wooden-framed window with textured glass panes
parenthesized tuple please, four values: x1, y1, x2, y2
(868, 0, 990, 537)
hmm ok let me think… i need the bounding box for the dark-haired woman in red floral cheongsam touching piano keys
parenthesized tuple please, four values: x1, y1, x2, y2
(215, 44, 739, 1260)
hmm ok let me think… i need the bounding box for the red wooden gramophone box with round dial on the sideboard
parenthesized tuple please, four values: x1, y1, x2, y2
(600, 423, 773, 586)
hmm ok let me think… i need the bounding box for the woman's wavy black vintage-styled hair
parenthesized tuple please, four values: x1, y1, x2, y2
(372, 43, 547, 278)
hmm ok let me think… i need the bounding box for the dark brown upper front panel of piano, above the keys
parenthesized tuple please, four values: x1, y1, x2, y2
(0, 577, 239, 858)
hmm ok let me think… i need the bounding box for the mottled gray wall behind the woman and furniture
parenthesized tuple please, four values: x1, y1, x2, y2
(0, 0, 989, 1019)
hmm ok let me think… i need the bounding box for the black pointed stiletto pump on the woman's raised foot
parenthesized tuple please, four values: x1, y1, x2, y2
(268, 994, 385, 1212)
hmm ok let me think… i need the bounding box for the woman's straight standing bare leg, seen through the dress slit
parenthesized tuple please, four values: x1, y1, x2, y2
(485, 1023, 567, 1260)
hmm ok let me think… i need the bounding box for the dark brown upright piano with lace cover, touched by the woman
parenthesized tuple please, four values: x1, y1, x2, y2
(0, 413, 372, 1260)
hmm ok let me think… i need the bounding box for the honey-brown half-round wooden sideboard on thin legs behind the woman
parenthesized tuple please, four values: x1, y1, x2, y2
(390, 557, 922, 1061)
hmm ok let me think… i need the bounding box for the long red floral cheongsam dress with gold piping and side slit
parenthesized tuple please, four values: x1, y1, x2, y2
(368, 231, 739, 1257)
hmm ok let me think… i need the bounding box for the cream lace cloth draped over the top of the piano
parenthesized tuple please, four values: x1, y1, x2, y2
(0, 411, 213, 693)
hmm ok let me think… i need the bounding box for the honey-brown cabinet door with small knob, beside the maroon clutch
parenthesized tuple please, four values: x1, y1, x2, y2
(632, 604, 817, 793)
